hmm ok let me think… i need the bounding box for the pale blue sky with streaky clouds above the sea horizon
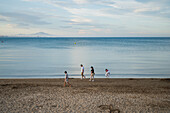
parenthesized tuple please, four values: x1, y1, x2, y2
(0, 0, 170, 37)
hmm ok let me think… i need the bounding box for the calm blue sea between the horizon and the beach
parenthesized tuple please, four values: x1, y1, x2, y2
(0, 37, 170, 78)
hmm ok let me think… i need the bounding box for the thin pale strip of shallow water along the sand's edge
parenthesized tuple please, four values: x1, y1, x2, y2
(0, 74, 170, 79)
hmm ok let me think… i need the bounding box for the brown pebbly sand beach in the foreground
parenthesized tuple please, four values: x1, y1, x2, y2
(0, 78, 170, 113)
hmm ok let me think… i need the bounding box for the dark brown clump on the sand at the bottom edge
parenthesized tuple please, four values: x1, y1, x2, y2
(98, 104, 120, 113)
